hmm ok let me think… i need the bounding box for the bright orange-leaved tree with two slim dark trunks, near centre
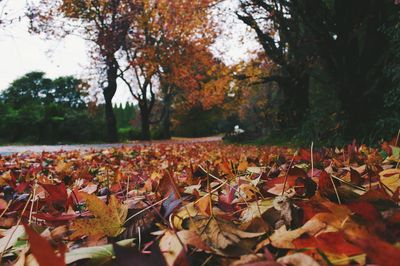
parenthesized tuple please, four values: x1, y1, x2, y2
(122, 0, 228, 139)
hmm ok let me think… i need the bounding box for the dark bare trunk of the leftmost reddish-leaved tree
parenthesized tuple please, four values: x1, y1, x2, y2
(103, 58, 118, 142)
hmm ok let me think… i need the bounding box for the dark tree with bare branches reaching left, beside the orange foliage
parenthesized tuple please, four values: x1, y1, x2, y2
(237, 0, 309, 126)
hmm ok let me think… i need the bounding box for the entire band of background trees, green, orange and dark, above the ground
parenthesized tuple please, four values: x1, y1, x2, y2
(0, 0, 400, 145)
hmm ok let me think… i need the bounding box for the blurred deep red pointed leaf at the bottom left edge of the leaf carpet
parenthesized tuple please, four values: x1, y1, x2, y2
(24, 225, 65, 266)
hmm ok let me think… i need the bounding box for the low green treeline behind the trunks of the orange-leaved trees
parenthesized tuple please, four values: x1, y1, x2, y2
(0, 72, 235, 144)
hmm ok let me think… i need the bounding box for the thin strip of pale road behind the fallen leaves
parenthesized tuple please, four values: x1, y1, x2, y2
(0, 136, 222, 155)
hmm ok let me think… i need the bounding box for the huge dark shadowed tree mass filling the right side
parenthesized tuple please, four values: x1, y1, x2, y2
(238, 0, 397, 141)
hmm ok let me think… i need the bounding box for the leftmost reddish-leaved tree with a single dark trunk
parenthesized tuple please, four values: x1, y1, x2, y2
(30, 0, 136, 142)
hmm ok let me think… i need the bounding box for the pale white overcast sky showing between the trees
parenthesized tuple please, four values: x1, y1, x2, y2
(0, 0, 258, 104)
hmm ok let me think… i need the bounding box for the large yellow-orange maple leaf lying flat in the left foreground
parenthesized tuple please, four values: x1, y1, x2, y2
(71, 193, 128, 239)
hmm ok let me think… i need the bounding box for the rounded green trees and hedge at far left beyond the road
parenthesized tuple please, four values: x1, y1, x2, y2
(0, 72, 104, 143)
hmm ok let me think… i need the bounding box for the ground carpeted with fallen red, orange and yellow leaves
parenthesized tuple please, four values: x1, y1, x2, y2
(0, 137, 400, 266)
